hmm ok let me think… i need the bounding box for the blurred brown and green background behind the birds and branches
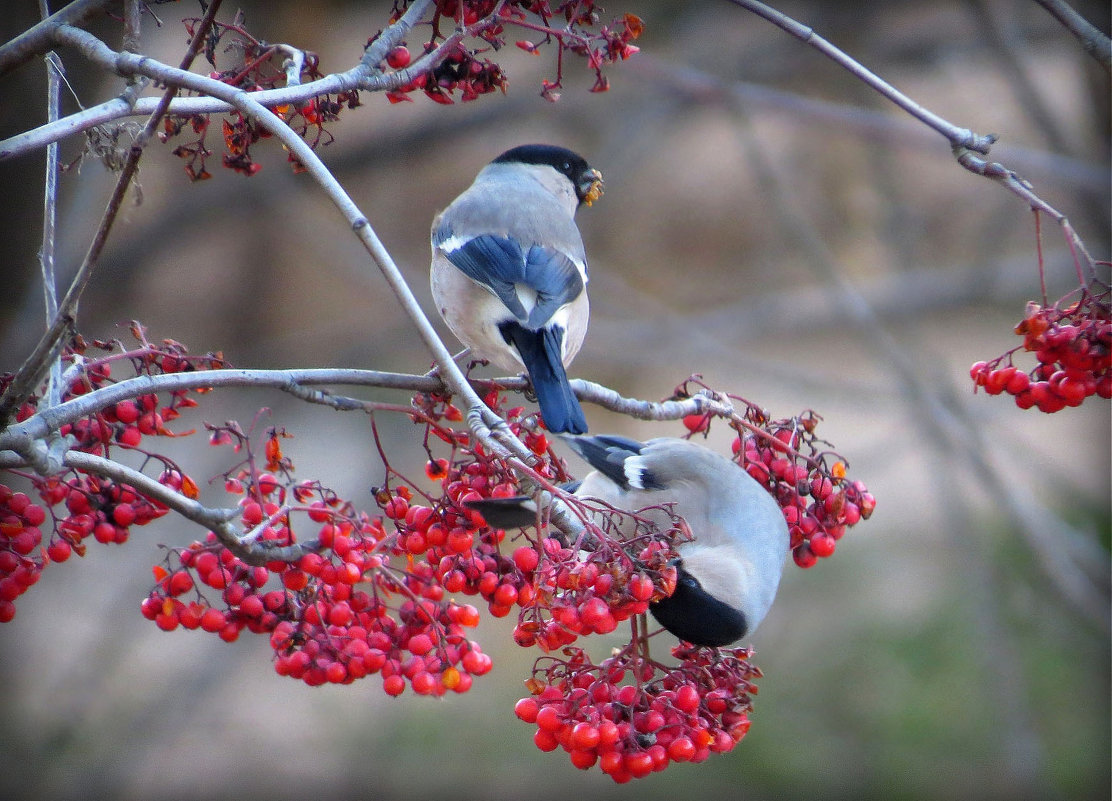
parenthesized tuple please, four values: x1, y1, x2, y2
(0, 0, 1110, 800)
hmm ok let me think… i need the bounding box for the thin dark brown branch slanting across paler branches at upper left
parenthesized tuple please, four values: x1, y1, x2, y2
(0, 0, 221, 425)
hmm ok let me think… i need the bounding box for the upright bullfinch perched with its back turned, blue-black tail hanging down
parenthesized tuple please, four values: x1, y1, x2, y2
(430, 145, 603, 434)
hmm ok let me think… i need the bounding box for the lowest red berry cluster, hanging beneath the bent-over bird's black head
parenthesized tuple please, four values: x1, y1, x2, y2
(514, 643, 761, 783)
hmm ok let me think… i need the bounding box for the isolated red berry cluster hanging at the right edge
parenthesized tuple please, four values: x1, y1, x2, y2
(970, 291, 1112, 414)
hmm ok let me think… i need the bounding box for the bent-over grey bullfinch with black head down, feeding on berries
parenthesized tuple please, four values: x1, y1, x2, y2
(468, 435, 788, 646)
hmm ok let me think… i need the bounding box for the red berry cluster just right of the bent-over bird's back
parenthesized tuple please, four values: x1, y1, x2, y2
(684, 407, 876, 567)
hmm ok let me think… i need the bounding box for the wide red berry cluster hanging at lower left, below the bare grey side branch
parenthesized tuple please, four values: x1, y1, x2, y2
(142, 460, 492, 695)
